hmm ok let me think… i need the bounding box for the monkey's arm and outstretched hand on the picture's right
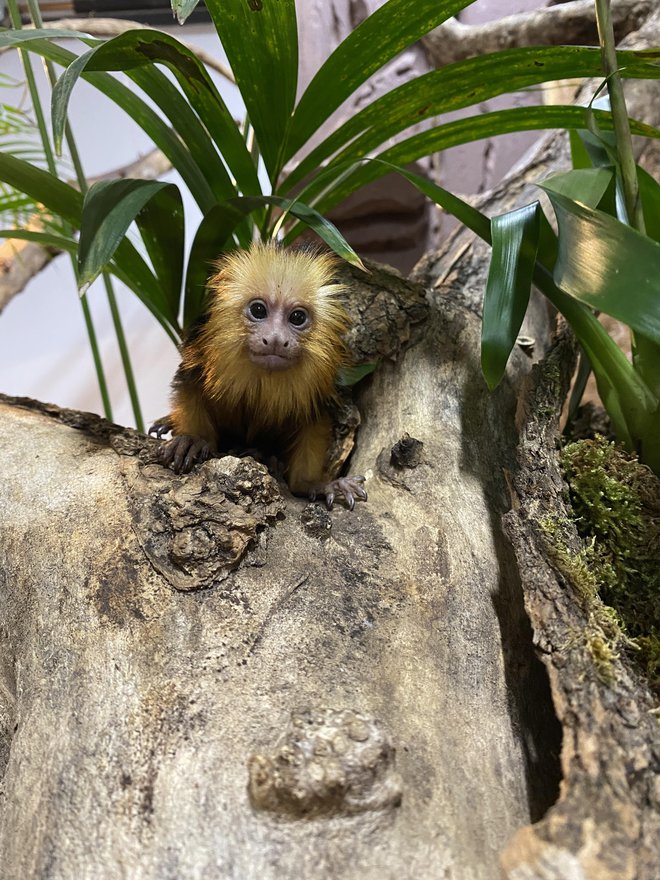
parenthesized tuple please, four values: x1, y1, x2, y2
(287, 416, 367, 510)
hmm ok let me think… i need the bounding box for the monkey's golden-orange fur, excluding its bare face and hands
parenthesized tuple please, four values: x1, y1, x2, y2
(171, 244, 348, 492)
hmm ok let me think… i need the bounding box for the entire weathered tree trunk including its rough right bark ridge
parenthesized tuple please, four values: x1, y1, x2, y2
(0, 6, 660, 880)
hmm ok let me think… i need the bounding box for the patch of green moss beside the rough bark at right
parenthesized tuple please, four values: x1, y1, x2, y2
(561, 435, 660, 691)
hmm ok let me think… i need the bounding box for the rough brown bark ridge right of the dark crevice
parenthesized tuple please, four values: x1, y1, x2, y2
(502, 330, 660, 880)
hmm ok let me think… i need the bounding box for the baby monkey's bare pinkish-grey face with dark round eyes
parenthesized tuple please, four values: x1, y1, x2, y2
(244, 297, 312, 371)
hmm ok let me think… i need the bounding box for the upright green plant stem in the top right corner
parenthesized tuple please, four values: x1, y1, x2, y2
(595, 0, 645, 232)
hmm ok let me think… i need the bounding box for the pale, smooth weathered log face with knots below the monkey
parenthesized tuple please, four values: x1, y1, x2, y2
(0, 262, 558, 878)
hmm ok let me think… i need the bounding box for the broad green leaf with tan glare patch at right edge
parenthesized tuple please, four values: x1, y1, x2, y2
(542, 180, 660, 343)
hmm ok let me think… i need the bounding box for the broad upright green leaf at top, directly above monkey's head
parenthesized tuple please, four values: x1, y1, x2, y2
(206, 0, 298, 182)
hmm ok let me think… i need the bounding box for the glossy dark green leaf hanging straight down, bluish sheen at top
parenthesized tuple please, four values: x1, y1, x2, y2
(481, 202, 541, 391)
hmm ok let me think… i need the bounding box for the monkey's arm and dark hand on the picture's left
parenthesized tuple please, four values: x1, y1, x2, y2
(149, 379, 216, 474)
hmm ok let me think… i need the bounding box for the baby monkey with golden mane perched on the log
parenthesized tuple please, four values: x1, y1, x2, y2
(149, 244, 367, 510)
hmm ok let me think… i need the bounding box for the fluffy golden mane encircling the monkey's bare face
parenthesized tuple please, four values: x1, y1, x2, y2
(199, 243, 348, 429)
